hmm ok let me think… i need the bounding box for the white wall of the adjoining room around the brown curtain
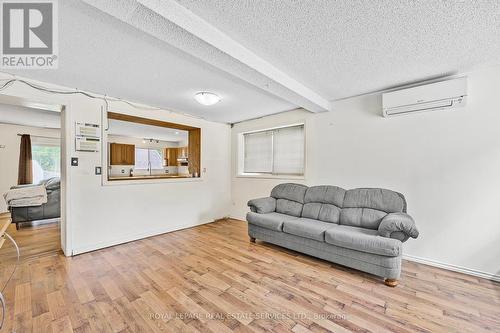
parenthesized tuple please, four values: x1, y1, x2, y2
(0, 122, 61, 212)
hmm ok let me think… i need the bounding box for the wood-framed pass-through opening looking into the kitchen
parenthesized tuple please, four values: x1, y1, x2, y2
(103, 112, 202, 181)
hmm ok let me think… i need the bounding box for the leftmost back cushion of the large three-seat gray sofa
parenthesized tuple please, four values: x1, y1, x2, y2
(271, 183, 307, 217)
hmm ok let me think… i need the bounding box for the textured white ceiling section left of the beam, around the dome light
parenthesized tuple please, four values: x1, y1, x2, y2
(7, 0, 295, 122)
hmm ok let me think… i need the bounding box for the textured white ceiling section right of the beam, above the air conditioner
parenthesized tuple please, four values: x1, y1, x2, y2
(177, 0, 500, 100)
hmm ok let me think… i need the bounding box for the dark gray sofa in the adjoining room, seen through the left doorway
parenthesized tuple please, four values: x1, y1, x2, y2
(9, 177, 61, 229)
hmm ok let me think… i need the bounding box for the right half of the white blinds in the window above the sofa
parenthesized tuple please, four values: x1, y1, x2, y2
(273, 125, 304, 175)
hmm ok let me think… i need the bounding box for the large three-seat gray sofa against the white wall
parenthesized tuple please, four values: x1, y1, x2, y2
(247, 183, 418, 287)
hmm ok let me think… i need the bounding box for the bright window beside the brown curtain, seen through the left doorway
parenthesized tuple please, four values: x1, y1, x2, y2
(31, 137, 61, 184)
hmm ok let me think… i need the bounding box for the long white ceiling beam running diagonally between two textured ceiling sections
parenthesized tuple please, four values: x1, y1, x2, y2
(83, 0, 331, 112)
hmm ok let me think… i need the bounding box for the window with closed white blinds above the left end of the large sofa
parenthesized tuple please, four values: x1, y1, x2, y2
(243, 125, 304, 176)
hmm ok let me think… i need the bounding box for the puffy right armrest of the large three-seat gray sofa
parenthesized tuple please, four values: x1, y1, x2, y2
(378, 213, 418, 242)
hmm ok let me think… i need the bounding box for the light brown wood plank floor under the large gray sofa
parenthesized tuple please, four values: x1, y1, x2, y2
(3, 220, 500, 333)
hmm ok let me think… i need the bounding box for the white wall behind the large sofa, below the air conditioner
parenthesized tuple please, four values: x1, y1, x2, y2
(231, 67, 500, 275)
